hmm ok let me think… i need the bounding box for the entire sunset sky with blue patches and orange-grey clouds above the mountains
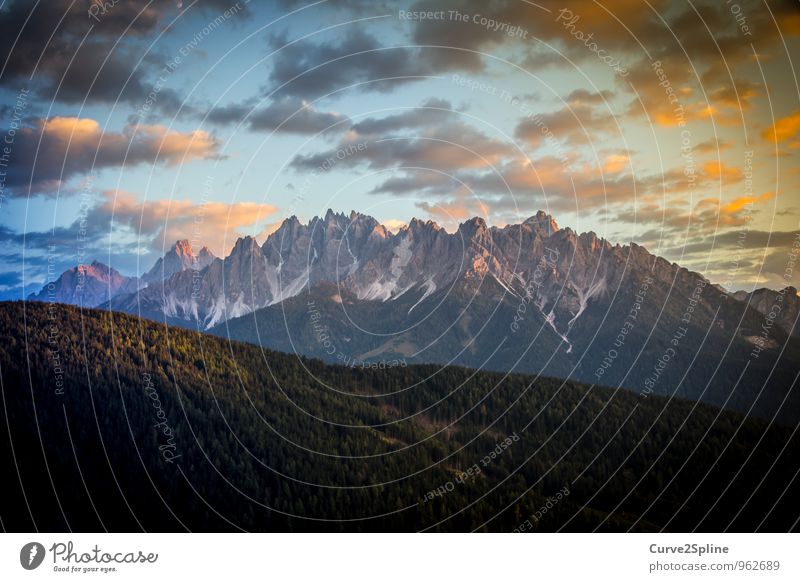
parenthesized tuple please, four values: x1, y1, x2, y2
(0, 0, 800, 299)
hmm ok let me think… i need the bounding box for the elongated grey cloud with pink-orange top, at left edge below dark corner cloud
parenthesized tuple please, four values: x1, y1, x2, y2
(7, 117, 219, 195)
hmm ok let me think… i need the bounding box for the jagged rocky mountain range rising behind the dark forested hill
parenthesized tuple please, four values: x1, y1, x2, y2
(28, 210, 800, 421)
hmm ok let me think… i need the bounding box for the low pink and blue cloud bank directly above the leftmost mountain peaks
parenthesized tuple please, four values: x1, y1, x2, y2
(0, 190, 277, 298)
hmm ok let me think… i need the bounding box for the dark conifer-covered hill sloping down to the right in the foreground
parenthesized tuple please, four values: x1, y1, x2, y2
(0, 303, 800, 531)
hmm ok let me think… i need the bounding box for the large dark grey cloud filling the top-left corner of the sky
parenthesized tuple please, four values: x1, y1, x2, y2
(0, 0, 246, 112)
